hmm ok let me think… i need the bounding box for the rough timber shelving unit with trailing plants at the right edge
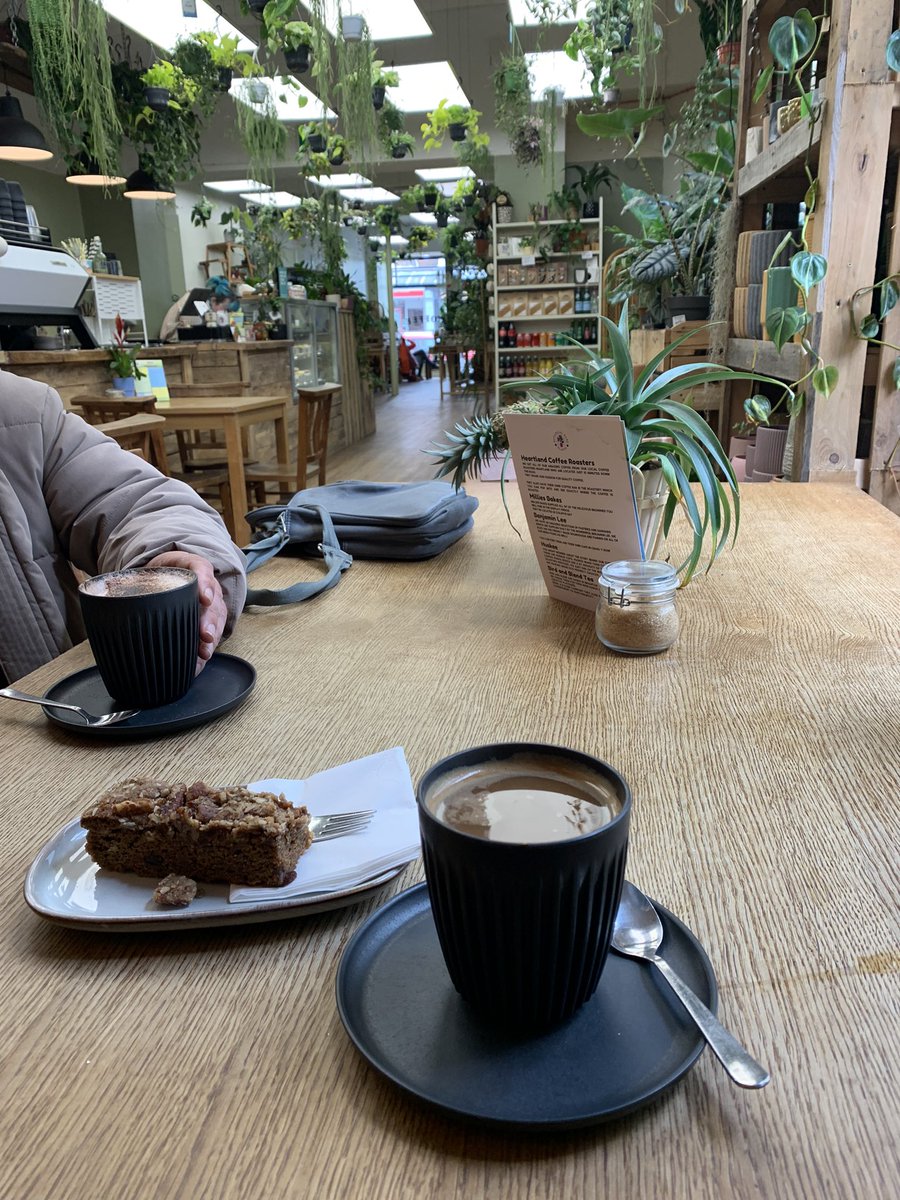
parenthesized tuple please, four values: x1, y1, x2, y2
(726, 0, 900, 499)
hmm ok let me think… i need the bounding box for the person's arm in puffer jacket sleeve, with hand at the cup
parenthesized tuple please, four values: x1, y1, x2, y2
(41, 388, 247, 634)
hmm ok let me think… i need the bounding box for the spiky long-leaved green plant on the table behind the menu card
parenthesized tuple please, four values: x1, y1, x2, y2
(426, 306, 796, 586)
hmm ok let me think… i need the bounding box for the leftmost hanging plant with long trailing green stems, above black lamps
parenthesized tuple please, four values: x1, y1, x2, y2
(28, 0, 124, 176)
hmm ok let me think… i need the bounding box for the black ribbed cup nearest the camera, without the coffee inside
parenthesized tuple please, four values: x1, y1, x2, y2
(416, 743, 631, 1030)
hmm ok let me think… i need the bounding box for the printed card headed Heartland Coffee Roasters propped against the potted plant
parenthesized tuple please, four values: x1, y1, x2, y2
(506, 413, 643, 610)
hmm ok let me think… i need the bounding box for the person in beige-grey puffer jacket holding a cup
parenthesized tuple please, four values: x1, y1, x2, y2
(0, 371, 246, 683)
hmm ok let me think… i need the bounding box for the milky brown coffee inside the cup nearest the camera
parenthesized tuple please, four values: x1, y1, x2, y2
(426, 752, 622, 845)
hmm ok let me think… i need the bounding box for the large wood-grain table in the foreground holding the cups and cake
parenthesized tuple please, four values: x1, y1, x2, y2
(0, 484, 900, 1200)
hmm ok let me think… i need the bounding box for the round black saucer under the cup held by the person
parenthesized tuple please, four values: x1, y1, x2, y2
(43, 654, 257, 739)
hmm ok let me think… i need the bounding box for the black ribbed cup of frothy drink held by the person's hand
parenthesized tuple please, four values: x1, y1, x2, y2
(78, 566, 200, 708)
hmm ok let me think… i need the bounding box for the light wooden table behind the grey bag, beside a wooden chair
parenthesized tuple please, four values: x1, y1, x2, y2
(158, 396, 289, 546)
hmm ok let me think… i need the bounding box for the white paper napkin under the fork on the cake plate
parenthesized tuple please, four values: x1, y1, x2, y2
(228, 746, 421, 904)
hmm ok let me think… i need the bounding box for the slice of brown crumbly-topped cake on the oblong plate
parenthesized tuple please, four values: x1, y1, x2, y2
(82, 779, 312, 888)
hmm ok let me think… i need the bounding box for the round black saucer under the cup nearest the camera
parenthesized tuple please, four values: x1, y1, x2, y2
(336, 883, 718, 1130)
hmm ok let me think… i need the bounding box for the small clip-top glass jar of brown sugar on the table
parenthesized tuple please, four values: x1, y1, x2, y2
(596, 560, 678, 654)
